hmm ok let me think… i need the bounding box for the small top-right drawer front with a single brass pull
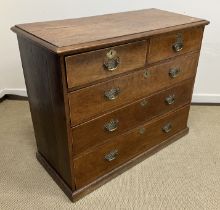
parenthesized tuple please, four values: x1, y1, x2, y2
(147, 27, 203, 63)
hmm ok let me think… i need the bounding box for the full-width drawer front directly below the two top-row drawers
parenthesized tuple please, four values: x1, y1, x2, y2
(69, 53, 198, 125)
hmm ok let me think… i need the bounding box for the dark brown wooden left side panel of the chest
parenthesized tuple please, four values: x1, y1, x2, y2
(18, 36, 74, 189)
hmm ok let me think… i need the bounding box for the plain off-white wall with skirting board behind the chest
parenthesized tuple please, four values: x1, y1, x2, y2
(0, 0, 220, 103)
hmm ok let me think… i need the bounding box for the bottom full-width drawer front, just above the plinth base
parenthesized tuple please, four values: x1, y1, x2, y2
(73, 106, 189, 189)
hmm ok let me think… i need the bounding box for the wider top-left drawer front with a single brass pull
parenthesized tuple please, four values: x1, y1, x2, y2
(65, 41, 147, 88)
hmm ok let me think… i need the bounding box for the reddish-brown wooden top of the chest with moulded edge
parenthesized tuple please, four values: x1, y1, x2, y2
(12, 9, 208, 52)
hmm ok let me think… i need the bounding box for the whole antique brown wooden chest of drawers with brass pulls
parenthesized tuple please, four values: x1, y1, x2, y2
(12, 9, 209, 200)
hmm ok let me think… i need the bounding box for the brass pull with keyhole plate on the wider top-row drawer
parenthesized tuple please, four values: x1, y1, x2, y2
(104, 50, 120, 71)
